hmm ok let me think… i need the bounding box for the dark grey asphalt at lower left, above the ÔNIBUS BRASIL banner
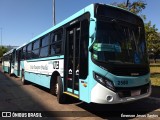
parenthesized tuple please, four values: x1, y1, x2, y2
(0, 71, 49, 112)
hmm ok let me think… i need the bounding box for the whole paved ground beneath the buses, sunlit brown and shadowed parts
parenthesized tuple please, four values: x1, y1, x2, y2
(0, 66, 160, 120)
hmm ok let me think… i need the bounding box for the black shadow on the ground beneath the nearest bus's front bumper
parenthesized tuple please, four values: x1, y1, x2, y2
(77, 98, 160, 119)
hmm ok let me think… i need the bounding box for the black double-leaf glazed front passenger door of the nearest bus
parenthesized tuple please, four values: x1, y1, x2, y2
(64, 23, 80, 97)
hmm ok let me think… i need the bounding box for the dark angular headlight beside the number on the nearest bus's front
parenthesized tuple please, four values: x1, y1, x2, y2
(93, 72, 114, 91)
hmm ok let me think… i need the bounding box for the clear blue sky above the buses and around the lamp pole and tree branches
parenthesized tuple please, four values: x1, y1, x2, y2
(0, 0, 160, 46)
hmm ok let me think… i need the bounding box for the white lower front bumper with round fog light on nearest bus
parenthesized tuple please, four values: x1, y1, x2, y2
(91, 83, 151, 104)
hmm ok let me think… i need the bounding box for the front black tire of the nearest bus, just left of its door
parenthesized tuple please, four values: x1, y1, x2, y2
(57, 76, 66, 104)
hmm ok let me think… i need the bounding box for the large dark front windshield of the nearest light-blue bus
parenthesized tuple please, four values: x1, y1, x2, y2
(93, 19, 147, 64)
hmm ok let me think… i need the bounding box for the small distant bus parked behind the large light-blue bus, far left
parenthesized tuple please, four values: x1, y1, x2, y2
(2, 48, 16, 75)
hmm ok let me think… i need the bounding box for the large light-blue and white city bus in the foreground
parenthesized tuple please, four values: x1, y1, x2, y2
(5, 3, 151, 104)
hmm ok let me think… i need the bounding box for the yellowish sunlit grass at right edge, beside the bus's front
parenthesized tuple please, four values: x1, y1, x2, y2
(150, 66, 160, 86)
